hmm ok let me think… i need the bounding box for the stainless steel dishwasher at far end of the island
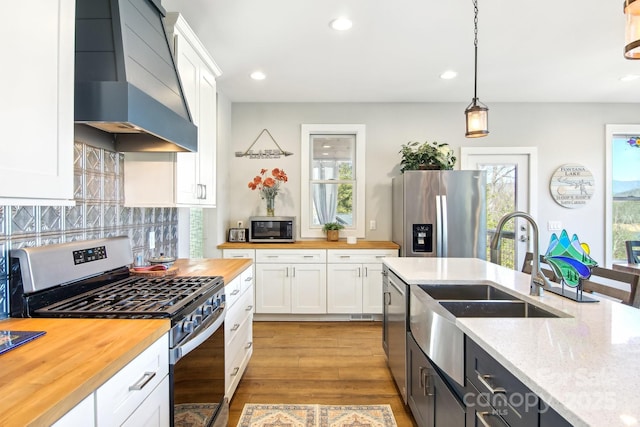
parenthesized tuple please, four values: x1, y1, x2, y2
(382, 266, 407, 404)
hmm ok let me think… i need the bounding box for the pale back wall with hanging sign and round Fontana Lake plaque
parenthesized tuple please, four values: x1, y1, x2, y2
(228, 103, 640, 264)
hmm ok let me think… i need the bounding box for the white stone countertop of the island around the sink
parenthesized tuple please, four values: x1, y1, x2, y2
(384, 258, 640, 427)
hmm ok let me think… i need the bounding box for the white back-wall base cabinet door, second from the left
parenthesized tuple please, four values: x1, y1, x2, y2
(290, 264, 327, 314)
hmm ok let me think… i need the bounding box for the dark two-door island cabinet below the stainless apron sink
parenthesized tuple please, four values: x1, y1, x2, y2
(407, 333, 466, 427)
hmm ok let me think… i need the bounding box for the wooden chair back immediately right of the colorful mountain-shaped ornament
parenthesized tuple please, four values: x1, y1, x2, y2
(582, 267, 640, 308)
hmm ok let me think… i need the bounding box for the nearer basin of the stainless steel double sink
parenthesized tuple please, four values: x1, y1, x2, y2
(439, 300, 560, 317)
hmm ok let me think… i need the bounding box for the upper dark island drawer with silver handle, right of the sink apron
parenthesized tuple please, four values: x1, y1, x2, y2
(465, 337, 539, 427)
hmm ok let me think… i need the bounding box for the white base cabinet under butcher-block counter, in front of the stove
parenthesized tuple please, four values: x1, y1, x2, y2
(53, 334, 171, 427)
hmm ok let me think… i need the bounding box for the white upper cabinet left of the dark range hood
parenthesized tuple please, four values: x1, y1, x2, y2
(0, 0, 75, 205)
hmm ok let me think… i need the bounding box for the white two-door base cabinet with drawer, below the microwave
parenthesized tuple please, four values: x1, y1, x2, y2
(256, 249, 327, 314)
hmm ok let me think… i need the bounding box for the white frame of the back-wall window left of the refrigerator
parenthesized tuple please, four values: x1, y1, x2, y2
(300, 124, 366, 238)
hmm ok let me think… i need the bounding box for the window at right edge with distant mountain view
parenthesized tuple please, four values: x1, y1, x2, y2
(605, 125, 640, 265)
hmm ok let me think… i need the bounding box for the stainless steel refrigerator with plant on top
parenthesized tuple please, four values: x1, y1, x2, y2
(392, 171, 487, 259)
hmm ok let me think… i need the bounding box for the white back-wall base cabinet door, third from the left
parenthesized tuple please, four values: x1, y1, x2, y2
(327, 264, 363, 313)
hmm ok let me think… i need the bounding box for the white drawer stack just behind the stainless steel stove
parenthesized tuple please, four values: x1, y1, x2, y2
(224, 267, 254, 400)
